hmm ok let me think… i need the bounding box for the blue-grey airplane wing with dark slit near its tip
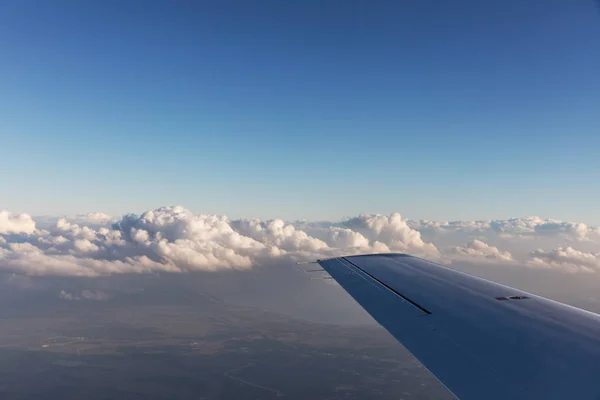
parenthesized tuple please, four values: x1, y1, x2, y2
(318, 254, 600, 400)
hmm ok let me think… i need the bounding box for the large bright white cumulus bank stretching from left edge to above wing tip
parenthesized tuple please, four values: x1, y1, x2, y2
(0, 206, 437, 276)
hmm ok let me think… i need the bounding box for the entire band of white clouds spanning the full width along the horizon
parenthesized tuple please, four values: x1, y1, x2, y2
(0, 206, 600, 276)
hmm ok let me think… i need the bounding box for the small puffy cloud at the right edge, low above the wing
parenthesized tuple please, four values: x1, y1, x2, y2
(528, 247, 600, 273)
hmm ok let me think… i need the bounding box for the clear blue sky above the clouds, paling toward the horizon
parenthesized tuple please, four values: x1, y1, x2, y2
(0, 0, 600, 223)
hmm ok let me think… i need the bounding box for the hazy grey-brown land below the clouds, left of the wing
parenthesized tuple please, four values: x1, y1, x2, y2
(0, 274, 451, 399)
